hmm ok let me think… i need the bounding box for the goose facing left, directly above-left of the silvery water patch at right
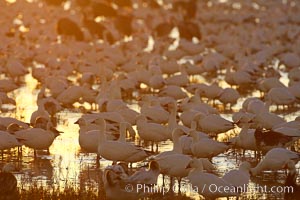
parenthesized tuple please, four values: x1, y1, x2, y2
(190, 130, 229, 158)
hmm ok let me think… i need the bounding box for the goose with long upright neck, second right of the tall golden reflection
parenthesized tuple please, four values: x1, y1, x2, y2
(98, 118, 149, 163)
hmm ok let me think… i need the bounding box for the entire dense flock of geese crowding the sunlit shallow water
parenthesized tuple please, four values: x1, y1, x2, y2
(0, 0, 300, 199)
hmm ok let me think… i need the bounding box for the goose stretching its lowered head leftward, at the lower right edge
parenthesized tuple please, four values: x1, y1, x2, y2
(250, 148, 300, 176)
